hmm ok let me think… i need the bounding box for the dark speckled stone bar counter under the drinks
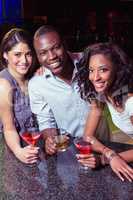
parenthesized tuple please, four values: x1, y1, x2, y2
(0, 138, 133, 200)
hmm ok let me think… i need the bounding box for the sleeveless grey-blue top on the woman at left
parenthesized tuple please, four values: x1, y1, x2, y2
(0, 68, 38, 133)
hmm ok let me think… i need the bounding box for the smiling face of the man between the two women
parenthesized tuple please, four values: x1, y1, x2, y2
(34, 32, 67, 76)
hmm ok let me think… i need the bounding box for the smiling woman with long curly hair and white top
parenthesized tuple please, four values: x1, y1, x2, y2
(78, 43, 133, 181)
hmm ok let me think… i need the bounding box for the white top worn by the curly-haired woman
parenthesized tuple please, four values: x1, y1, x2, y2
(106, 97, 133, 136)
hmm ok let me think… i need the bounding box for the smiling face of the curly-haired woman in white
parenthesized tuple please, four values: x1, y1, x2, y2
(89, 54, 113, 93)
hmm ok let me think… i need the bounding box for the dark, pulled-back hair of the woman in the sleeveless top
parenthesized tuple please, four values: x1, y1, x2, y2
(0, 28, 37, 76)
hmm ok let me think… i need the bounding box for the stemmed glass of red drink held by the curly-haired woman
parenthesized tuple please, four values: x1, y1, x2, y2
(74, 137, 92, 170)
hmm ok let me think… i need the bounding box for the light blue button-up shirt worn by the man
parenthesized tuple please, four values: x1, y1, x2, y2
(28, 54, 90, 136)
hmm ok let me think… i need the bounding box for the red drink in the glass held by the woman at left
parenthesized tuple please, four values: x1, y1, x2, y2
(21, 132, 41, 146)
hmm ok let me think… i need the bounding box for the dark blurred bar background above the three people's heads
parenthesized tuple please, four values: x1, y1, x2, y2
(0, 0, 133, 56)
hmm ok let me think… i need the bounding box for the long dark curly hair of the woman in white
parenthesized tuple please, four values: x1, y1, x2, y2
(78, 43, 133, 106)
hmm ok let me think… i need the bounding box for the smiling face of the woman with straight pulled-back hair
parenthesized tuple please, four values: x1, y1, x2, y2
(3, 42, 32, 76)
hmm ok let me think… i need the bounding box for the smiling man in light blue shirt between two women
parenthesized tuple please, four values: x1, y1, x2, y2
(29, 25, 108, 153)
